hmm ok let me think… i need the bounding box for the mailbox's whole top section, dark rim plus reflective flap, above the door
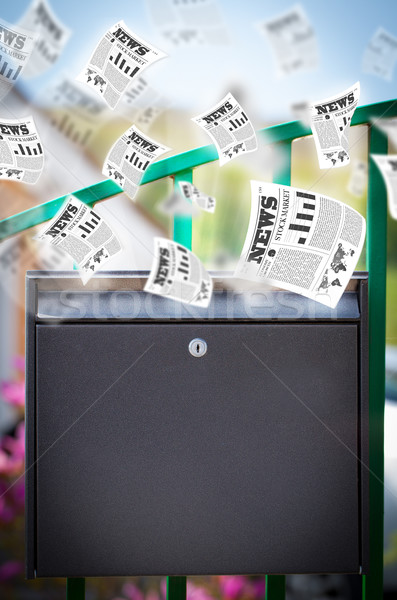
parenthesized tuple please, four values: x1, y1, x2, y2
(26, 271, 368, 322)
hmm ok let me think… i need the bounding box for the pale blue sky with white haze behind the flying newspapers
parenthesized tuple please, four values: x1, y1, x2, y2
(0, 0, 397, 126)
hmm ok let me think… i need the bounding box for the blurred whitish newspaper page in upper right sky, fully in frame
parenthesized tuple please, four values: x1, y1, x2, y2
(257, 4, 318, 77)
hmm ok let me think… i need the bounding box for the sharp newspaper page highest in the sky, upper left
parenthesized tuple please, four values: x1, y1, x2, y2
(76, 21, 166, 109)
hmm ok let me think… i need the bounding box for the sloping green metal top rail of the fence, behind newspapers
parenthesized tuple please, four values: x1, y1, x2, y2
(0, 100, 397, 241)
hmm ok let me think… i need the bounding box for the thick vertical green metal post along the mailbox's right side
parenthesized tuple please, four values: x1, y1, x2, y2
(363, 127, 387, 600)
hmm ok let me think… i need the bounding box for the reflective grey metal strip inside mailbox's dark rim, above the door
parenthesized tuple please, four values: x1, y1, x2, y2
(37, 290, 360, 320)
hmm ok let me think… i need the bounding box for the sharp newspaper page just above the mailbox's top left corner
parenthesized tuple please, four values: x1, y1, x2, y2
(35, 196, 121, 285)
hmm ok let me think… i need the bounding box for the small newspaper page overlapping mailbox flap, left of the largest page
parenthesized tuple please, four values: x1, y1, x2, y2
(144, 237, 212, 308)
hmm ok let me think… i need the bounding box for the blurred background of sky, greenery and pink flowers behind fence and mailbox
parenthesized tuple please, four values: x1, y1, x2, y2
(0, 0, 397, 600)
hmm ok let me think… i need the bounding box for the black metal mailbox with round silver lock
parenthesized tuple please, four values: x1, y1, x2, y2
(26, 271, 368, 578)
